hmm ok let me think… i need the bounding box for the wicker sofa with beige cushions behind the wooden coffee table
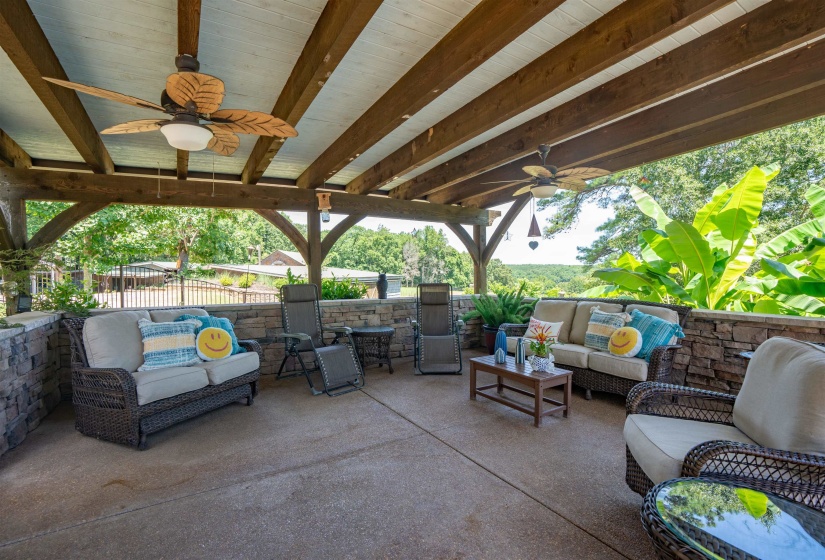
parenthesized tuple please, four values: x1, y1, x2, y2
(503, 298, 690, 399)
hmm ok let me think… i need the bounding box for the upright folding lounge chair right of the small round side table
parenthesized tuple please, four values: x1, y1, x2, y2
(413, 284, 464, 374)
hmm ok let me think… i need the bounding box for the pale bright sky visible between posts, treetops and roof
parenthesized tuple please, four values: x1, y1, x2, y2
(286, 199, 613, 264)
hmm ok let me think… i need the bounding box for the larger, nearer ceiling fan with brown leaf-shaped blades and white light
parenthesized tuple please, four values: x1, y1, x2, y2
(43, 54, 298, 156)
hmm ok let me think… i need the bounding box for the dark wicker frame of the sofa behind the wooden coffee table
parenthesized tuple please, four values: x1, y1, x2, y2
(502, 298, 691, 400)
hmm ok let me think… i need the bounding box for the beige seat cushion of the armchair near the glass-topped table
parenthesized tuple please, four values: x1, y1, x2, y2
(624, 414, 753, 484)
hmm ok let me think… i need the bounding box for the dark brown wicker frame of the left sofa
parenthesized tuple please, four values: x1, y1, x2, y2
(63, 310, 263, 450)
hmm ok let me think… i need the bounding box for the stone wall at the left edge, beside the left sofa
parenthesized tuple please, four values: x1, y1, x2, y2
(0, 312, 61, 455)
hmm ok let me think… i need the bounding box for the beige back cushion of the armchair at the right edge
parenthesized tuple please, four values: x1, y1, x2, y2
(733, 337, 825, 454)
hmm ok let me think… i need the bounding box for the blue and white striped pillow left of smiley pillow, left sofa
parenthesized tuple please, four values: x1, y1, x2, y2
(138, 319, 201, 371)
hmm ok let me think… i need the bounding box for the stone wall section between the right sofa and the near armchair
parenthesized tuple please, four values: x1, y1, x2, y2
(674, 309, 825, 394)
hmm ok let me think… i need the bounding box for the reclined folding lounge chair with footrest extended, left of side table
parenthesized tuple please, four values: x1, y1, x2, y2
(277, 284, 364, 397)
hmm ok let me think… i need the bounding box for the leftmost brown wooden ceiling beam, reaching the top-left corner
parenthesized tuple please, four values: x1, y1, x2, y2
(0, 0, 115, 173)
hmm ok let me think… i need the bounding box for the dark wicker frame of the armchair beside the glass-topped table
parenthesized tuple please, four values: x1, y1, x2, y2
(625, 383, 825, 511)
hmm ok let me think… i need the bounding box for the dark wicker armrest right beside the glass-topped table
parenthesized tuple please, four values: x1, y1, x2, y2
(682, 440, 825, 511)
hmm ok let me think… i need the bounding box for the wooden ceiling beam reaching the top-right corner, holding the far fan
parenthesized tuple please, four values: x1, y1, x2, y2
(390, 0, 825, 203)
